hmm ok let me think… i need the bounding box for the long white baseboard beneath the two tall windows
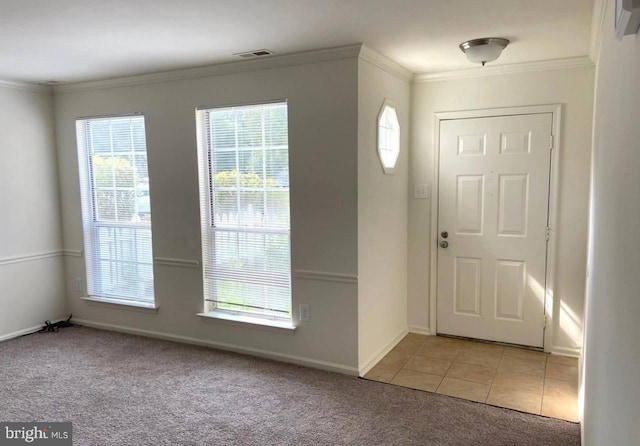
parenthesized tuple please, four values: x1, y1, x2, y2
(71, 318, 358, 376)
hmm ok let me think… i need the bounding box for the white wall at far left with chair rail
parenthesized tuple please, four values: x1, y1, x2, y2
(0, 85, 67, 339)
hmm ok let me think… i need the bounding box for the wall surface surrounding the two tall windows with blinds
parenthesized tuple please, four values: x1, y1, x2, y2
(55, 53, 358, 374)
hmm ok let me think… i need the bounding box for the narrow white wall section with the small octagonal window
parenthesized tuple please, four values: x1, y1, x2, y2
(358, 59, 410, 373)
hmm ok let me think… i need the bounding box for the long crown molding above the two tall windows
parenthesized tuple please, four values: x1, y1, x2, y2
(53, 43, 362, 94)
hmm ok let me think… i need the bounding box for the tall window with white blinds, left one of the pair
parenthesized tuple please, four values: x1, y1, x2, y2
(76, 115, 154, 306)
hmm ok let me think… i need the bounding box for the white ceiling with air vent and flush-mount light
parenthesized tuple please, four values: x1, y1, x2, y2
(0, 0, 593, 82)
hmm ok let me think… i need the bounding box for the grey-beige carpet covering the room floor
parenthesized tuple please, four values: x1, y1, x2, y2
(0, 328, 580, 446)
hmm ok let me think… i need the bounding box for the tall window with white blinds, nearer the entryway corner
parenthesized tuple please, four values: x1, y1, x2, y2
(197, 102, 291, 320)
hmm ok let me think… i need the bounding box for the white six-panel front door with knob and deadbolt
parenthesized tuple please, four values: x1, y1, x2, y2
(437, 113, 553, 347)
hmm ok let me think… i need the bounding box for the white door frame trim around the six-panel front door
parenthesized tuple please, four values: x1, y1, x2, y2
(429, 104, 562, 353)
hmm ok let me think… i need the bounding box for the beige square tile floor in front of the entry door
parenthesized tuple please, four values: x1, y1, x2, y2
(364, 333, 578, 421)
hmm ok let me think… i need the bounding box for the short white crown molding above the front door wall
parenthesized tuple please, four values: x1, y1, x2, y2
(413, 56, 594, 83)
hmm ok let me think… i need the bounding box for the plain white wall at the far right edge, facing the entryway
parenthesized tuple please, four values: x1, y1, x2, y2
(582, 1, 640, 446)
